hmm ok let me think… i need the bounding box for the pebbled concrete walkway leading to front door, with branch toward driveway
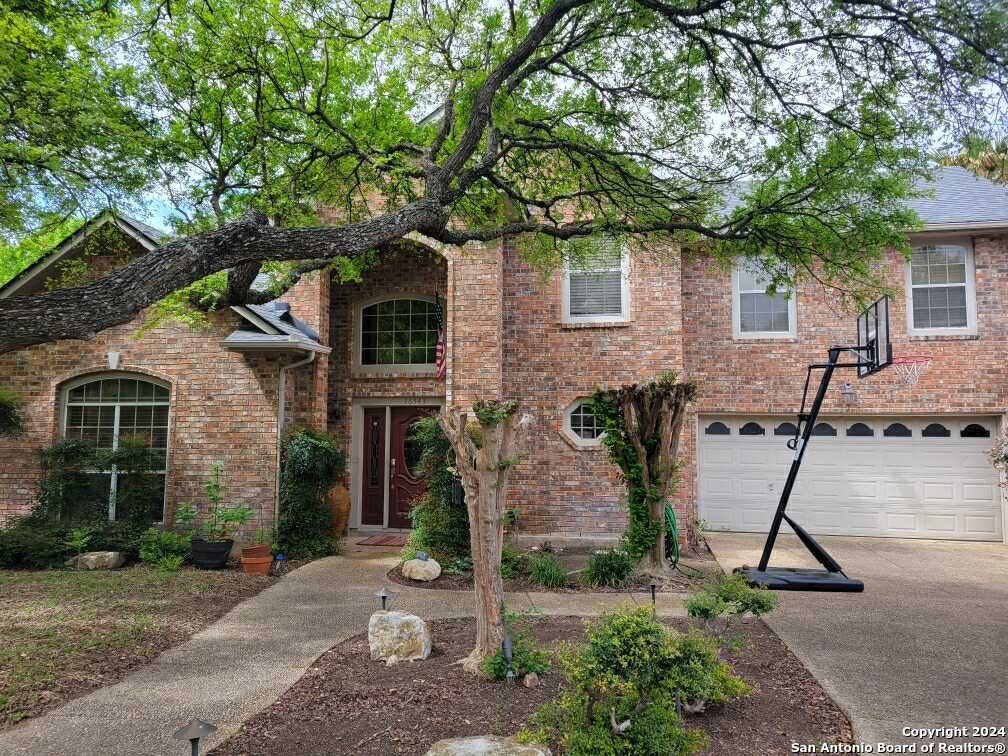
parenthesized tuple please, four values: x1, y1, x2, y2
(0, 546, 682, 756)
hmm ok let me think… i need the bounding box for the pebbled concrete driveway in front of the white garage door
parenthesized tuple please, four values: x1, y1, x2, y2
(707, 533, 1008, 753)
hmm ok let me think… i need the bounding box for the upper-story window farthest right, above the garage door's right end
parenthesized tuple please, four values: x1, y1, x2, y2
(906, 243, 977, 336)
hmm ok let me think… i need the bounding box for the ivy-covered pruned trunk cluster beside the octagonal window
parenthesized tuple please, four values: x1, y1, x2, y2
(592, 379, 696, 559)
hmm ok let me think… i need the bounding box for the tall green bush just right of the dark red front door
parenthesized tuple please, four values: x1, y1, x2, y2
(404, 416, 470, 562)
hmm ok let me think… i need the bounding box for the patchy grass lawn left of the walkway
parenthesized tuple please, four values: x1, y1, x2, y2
(0, 565, 273, 729)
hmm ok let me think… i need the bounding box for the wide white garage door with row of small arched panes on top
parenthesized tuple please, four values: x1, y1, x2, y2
(698, 417, 1003, 540)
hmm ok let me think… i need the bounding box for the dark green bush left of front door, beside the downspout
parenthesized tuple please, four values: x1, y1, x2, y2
(276, 430, 346, 559)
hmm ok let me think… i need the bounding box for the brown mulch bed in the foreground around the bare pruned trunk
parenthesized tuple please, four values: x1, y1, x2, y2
(212, 618, 852, 756)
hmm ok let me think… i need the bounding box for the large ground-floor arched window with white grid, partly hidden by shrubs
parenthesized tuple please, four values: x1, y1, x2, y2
(62, 374, 171, 521)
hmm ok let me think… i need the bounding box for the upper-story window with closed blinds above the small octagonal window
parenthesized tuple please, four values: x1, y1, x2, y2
(563, 237, 630, 323)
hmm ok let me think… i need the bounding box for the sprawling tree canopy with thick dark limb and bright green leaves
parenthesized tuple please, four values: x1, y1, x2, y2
(0, 0, 1008, 351)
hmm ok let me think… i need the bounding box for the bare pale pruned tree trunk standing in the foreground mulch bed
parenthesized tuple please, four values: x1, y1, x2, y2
(439, 402, 524, 672)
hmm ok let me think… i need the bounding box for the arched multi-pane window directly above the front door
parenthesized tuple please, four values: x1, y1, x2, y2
(361, 299, 438, 365)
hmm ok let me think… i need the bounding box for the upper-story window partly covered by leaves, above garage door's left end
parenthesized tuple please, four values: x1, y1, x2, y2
(732, 265, 797, 339)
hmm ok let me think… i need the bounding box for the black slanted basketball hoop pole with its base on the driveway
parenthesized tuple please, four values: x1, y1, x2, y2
(736, 347, 874, 592)
